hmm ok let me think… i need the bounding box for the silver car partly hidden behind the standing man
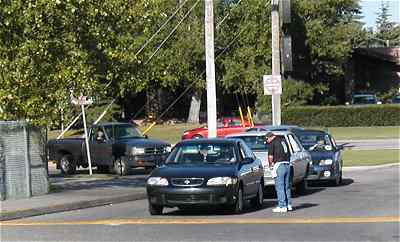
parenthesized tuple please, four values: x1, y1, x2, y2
(227, 131, 311, 193)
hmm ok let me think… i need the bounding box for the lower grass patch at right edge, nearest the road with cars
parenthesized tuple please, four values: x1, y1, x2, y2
(343, 150, 400, 166)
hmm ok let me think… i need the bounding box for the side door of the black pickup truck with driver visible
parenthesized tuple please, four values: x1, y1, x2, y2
(89, 126, 113, 165)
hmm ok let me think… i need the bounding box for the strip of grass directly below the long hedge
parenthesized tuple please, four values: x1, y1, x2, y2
(322, 126, 400, 140)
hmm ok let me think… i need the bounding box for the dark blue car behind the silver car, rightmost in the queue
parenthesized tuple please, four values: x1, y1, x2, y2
(290, 130, 343, 186)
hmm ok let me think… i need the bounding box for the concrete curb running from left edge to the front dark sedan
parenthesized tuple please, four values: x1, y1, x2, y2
(0, 192, 147, 221)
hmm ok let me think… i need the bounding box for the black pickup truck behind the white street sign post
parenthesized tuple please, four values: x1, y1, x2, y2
(48, 123, 171, 175)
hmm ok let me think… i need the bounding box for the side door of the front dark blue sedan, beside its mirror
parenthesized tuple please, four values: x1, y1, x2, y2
(238, 141, 255, 196)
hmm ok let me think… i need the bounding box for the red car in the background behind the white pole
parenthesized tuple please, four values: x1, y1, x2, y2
(182, 118, 252, 140)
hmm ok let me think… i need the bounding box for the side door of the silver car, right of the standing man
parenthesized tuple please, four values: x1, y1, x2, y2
(286, 134, 308, 183)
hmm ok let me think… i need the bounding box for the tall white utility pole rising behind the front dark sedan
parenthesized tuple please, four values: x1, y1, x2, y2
(204, 0, 217, 138)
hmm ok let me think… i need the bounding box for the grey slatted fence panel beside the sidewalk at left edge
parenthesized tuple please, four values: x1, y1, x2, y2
(0, 121, 49, 200)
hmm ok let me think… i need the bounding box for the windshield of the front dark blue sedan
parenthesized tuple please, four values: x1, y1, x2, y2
(166, 143, 237, 164)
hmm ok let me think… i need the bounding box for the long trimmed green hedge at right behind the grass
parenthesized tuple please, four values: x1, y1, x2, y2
(282, 104, 400, 127)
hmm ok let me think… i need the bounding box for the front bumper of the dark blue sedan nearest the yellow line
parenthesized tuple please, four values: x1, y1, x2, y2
(147, 186, 237, 207)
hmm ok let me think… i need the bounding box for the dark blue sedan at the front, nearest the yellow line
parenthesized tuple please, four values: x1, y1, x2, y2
(146, 139, 264, 215)
